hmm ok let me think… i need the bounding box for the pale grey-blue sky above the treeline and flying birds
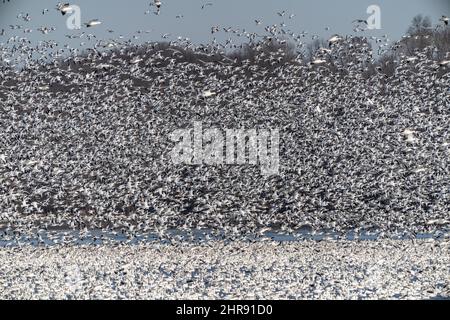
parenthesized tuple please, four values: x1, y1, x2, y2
(0, 0, 450, 49)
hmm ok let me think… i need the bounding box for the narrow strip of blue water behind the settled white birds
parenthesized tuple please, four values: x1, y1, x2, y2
(0, 229, 450, 248)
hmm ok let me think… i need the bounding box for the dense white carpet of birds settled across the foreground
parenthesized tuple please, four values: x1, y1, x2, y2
(0, 240, 450, 299)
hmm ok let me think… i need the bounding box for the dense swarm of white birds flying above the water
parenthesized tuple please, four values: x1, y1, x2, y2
(0, 0, 450, 245)
